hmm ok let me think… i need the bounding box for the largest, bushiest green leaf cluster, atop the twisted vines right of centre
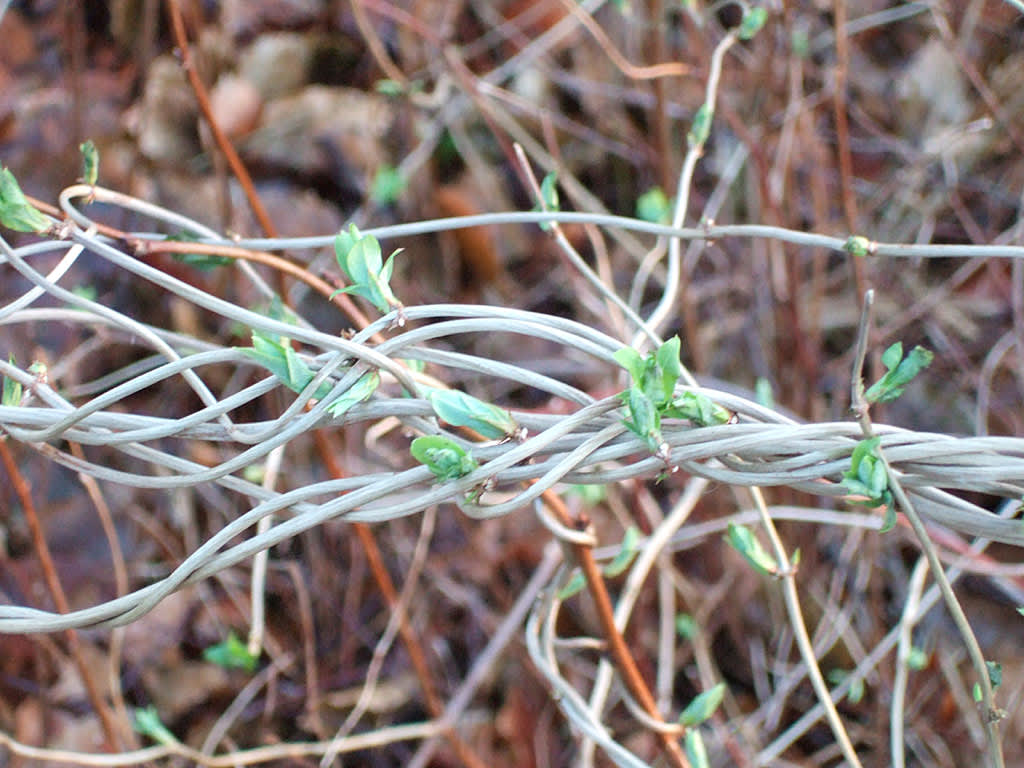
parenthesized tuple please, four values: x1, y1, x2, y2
(613, 336, 732, 453)
